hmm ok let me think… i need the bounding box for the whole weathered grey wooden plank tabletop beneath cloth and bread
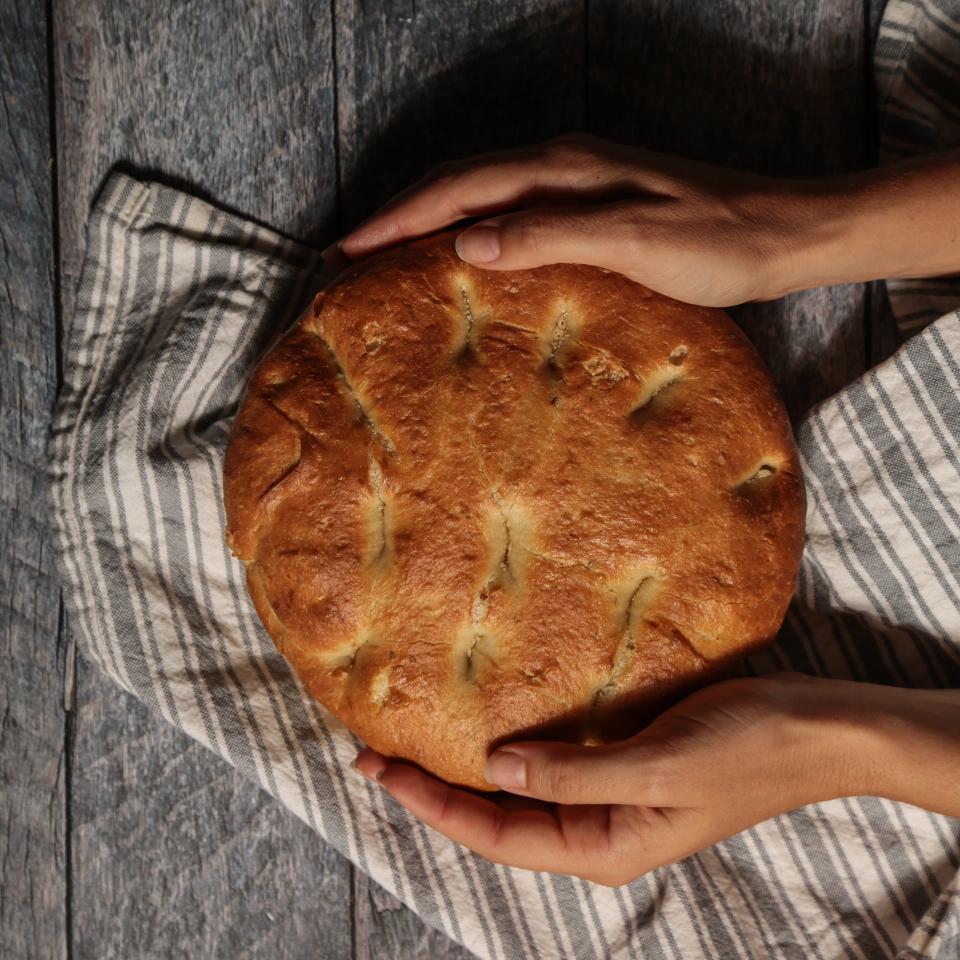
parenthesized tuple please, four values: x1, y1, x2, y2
(0, 0, 893, 960)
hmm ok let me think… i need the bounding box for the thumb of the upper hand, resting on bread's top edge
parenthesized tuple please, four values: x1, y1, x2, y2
(456, 203, 641, 273)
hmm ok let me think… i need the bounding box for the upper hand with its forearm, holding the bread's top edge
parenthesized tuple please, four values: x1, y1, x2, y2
(339, 134, 960, 306)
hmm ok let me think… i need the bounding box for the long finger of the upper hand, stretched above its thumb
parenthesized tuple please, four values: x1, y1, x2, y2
(343, 141, 631, 257)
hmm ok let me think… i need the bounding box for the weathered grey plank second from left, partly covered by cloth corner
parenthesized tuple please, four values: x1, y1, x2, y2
(49, 0, 352, 960)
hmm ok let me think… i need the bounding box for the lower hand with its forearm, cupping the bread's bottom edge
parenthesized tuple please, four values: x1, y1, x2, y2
(357, 674, 960, 886)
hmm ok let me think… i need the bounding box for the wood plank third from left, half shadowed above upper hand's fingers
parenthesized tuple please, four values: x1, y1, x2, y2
(336, 0, 586, 960)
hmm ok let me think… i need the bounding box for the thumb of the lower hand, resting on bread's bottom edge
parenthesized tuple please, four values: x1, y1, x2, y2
(484, 738, 670, 806)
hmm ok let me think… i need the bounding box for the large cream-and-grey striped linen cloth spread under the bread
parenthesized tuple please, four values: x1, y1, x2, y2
(50, 2, 960, 960)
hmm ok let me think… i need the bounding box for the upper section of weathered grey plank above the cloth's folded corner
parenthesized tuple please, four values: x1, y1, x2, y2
(54, 0, 336, 317)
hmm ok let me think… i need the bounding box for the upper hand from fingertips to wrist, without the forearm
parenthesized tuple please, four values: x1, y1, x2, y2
(340, 134, 828, 306)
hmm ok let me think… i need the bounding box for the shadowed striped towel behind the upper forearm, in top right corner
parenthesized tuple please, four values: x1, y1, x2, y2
(873, 0, 960, 336)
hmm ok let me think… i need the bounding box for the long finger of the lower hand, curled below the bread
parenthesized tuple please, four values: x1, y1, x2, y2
(378, 762, 585, 873)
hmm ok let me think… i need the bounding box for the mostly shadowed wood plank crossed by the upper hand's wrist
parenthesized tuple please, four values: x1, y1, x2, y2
(588, 0, 866, 416)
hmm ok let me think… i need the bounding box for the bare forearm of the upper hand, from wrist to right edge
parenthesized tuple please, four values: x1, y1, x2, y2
(761, 150, 960, 293)
